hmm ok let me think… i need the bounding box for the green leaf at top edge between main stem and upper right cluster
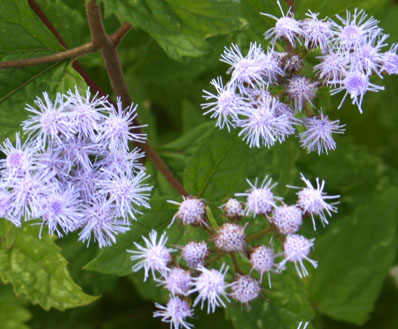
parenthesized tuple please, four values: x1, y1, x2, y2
(102, 0, 246, 60)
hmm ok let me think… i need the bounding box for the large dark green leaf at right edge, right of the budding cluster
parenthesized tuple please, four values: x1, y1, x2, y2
(310, 188, 398, 325)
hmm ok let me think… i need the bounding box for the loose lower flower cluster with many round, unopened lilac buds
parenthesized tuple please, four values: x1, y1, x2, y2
(127, 175, 332, 328)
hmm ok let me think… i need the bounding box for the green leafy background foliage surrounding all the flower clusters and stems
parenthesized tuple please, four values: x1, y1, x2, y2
(0, 0, 398, 329)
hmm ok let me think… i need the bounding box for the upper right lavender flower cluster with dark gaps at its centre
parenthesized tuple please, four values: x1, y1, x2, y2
(202, 1, 398, 154)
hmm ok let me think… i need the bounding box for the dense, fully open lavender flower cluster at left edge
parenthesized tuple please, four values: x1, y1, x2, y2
(0, 88, 152, 248)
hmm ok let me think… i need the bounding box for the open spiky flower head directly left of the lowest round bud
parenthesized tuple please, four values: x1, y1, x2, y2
(189, 264, 229, 313)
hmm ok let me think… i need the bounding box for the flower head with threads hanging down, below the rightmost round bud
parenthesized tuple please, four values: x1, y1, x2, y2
(279, 234, 318, 278)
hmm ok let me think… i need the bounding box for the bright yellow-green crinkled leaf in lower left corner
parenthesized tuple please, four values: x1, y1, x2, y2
(0, 219, 98, 310)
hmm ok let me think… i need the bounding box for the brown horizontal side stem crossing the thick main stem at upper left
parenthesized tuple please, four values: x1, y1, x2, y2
(0, 23, 131, 69)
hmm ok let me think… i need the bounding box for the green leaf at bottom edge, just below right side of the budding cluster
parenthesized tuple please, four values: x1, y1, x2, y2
(226, 269, 314, 329)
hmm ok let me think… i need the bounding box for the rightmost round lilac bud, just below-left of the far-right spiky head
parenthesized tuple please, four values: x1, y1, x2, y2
(272, 205, 303, 234)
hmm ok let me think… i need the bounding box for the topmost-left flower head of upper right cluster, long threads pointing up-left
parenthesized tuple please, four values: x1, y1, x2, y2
(262, 0, 303, 47)
